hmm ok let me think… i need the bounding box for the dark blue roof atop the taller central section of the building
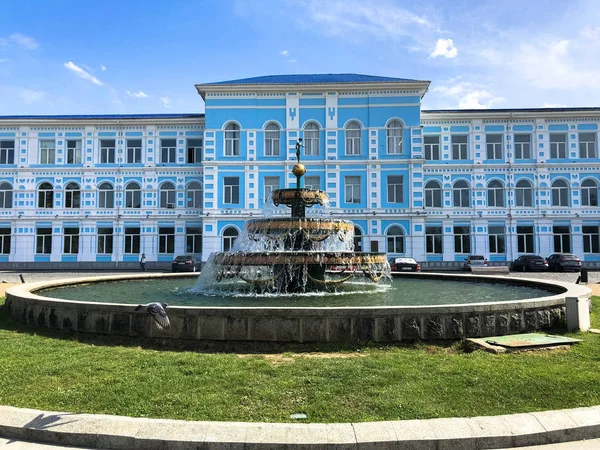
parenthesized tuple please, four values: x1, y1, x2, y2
(202, 73, 421, 85)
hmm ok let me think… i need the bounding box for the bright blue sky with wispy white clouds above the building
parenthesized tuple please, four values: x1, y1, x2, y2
(0, 0, 600, 115)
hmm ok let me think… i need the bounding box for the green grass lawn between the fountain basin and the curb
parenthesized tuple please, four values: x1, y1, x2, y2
(0, 297, 600, 422)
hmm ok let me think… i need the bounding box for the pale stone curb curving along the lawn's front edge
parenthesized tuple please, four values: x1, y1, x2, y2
(0, 406, 600, 450)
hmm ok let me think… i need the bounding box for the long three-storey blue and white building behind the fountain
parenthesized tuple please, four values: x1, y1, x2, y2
(0, 74, 600, 267)
